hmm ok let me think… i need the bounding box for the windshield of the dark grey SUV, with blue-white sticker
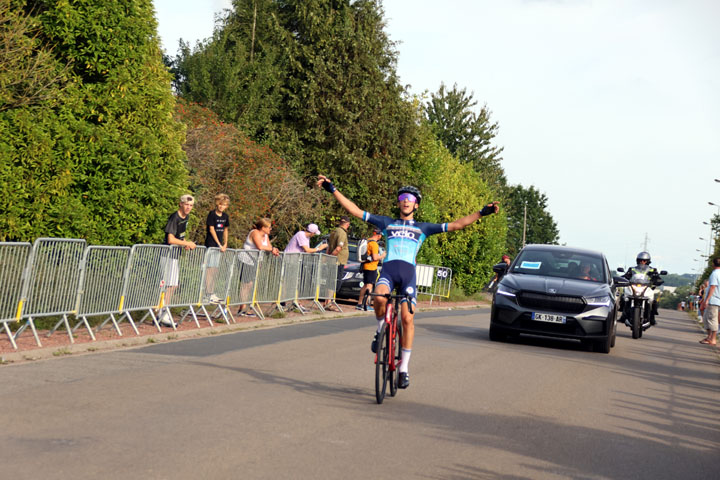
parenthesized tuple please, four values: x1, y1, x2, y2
(512, 249, 606, 282)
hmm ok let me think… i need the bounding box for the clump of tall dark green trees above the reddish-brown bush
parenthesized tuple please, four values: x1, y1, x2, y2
(173, 0, 417, 214)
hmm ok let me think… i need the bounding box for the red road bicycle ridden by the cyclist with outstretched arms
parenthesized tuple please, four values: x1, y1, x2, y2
(363, 292, 413, 404)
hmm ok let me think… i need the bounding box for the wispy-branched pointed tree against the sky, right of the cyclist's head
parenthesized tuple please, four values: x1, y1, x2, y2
(425, 84, 507, 191)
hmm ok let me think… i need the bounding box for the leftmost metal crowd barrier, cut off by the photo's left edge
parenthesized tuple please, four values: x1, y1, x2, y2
(0, 242, 32, 350)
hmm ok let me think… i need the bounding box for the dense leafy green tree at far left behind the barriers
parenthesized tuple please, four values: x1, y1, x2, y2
(0, 0, 187, 244)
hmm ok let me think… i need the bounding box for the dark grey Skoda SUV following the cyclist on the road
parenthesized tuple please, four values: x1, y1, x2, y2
(490, 245, 627, 353)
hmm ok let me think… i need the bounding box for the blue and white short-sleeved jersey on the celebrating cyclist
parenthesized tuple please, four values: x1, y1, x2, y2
(362, 212, 448, 265)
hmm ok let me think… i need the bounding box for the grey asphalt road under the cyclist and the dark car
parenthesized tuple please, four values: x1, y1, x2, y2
(0, 309, 720, 480)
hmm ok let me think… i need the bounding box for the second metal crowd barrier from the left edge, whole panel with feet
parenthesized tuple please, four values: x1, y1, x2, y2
(15, 238, 85, 347)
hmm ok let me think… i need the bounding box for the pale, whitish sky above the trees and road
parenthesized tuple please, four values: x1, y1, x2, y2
(154, 0, 720, 274)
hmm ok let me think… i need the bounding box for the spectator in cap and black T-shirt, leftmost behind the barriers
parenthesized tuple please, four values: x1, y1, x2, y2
(160, 195, 196, 327)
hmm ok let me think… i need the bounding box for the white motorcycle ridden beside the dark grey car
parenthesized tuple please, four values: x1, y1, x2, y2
(618, 268, 667, 338)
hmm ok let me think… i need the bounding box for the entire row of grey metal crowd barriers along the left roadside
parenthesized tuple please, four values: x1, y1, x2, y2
(0, 238, 452, 349)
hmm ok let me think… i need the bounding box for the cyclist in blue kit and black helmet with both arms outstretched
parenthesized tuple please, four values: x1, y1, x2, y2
(317, 175, 499, 388)
